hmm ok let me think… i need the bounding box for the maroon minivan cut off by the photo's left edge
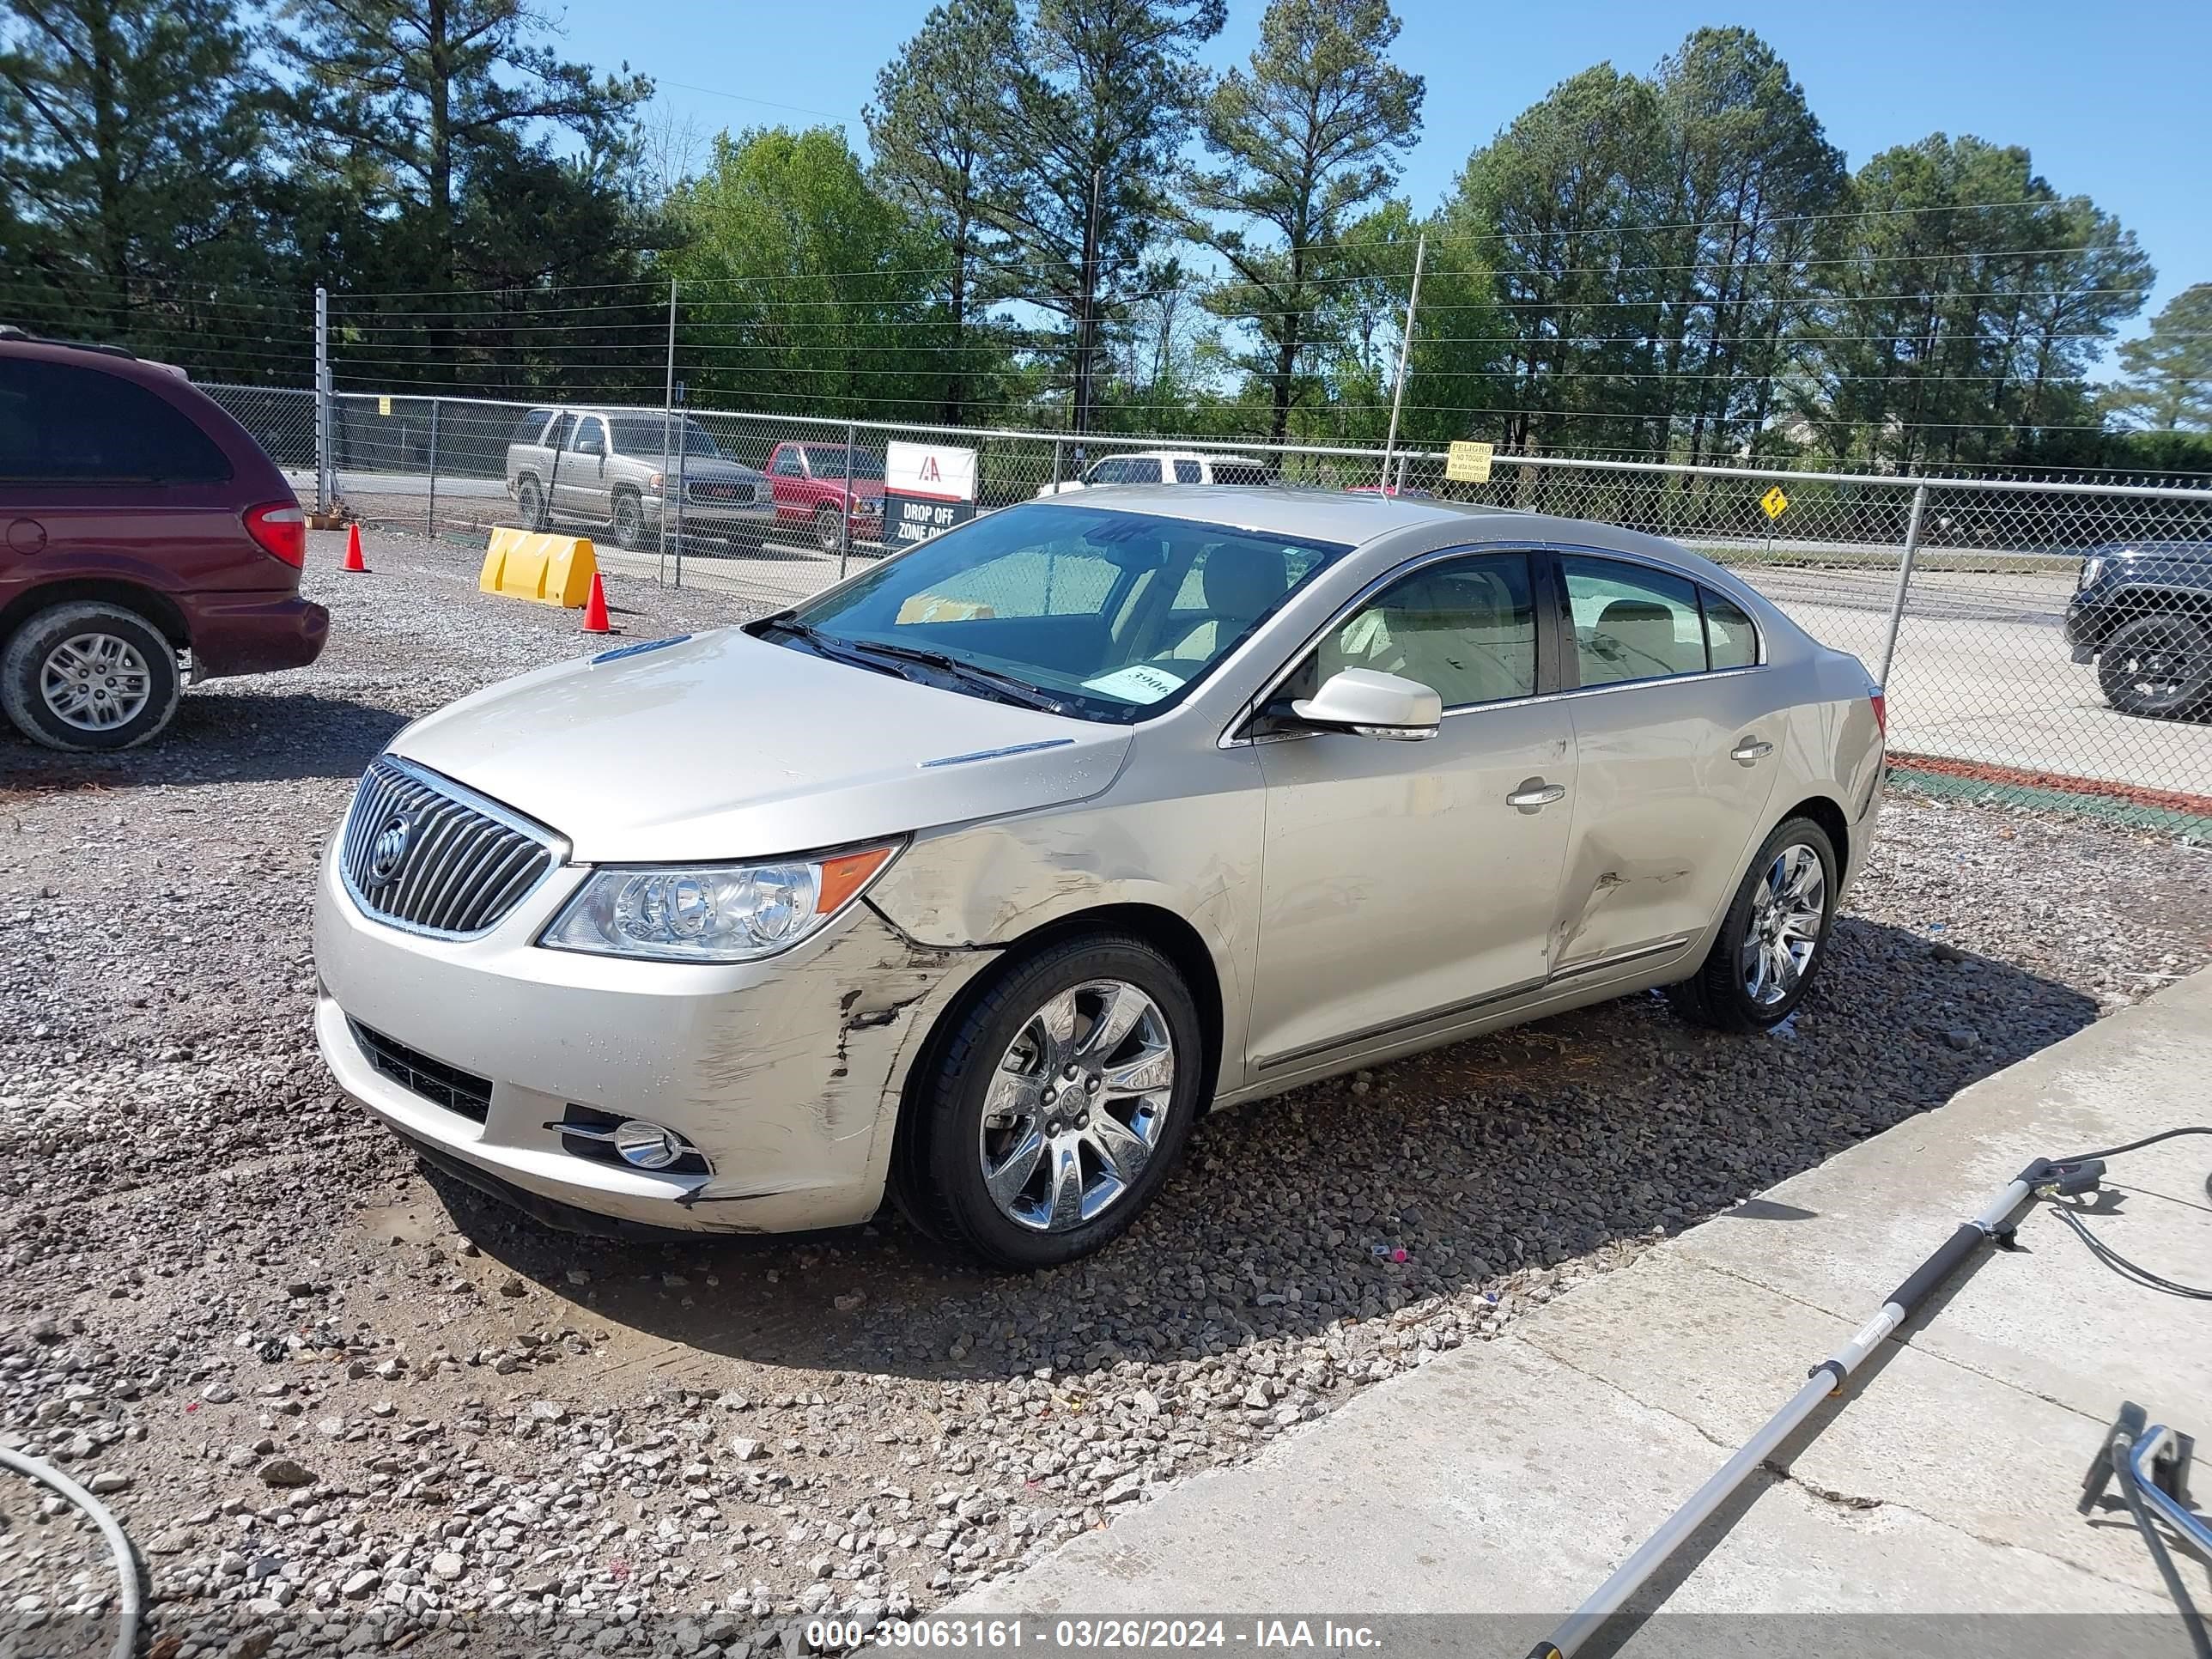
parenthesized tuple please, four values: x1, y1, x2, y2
(0, 330, 330, 750)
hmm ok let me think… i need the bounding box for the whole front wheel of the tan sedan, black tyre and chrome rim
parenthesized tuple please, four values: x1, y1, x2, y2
(900, 933, 1203, 1270)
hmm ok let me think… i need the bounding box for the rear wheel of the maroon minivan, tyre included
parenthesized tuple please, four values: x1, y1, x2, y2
(0, 599, 181, 750)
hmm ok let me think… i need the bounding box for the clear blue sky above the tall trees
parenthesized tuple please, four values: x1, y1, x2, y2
(564, 0, 2212, 344)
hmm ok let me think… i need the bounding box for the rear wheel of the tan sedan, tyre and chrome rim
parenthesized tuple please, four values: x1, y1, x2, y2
(1668, 818, 1836, 1033)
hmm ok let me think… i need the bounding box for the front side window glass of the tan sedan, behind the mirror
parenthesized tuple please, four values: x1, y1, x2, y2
(1312, 553, 1535, 708)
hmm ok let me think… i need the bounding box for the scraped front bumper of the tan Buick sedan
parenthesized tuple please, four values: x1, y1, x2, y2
(314, 836, 988, 1232)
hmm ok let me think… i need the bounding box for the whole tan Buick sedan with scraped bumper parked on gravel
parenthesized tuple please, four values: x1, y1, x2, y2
(314, 487, 1882, 1267)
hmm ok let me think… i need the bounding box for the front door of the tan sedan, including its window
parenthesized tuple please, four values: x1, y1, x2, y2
(1248, 550, 1577, 1079)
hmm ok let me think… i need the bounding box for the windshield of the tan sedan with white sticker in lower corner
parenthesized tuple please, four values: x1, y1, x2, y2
(757, 502, 1349, 721)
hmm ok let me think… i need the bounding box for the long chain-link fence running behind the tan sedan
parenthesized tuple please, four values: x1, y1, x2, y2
(208, 385, 2212, 836)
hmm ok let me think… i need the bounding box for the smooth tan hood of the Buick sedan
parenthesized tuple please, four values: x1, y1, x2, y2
(392, 629, 1130, 863)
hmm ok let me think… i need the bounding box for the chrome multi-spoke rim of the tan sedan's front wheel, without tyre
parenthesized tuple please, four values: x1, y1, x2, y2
(978, 980, 1175, 1232)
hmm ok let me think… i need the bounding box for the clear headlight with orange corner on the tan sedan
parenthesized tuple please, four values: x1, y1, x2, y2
(538, 848, 898, 963)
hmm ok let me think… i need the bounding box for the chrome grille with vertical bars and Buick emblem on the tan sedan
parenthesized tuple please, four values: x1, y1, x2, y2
(338, 754, 553, 938)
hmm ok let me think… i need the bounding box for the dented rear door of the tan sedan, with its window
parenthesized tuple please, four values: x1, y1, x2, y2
(1553, 553, 1783, 975)
